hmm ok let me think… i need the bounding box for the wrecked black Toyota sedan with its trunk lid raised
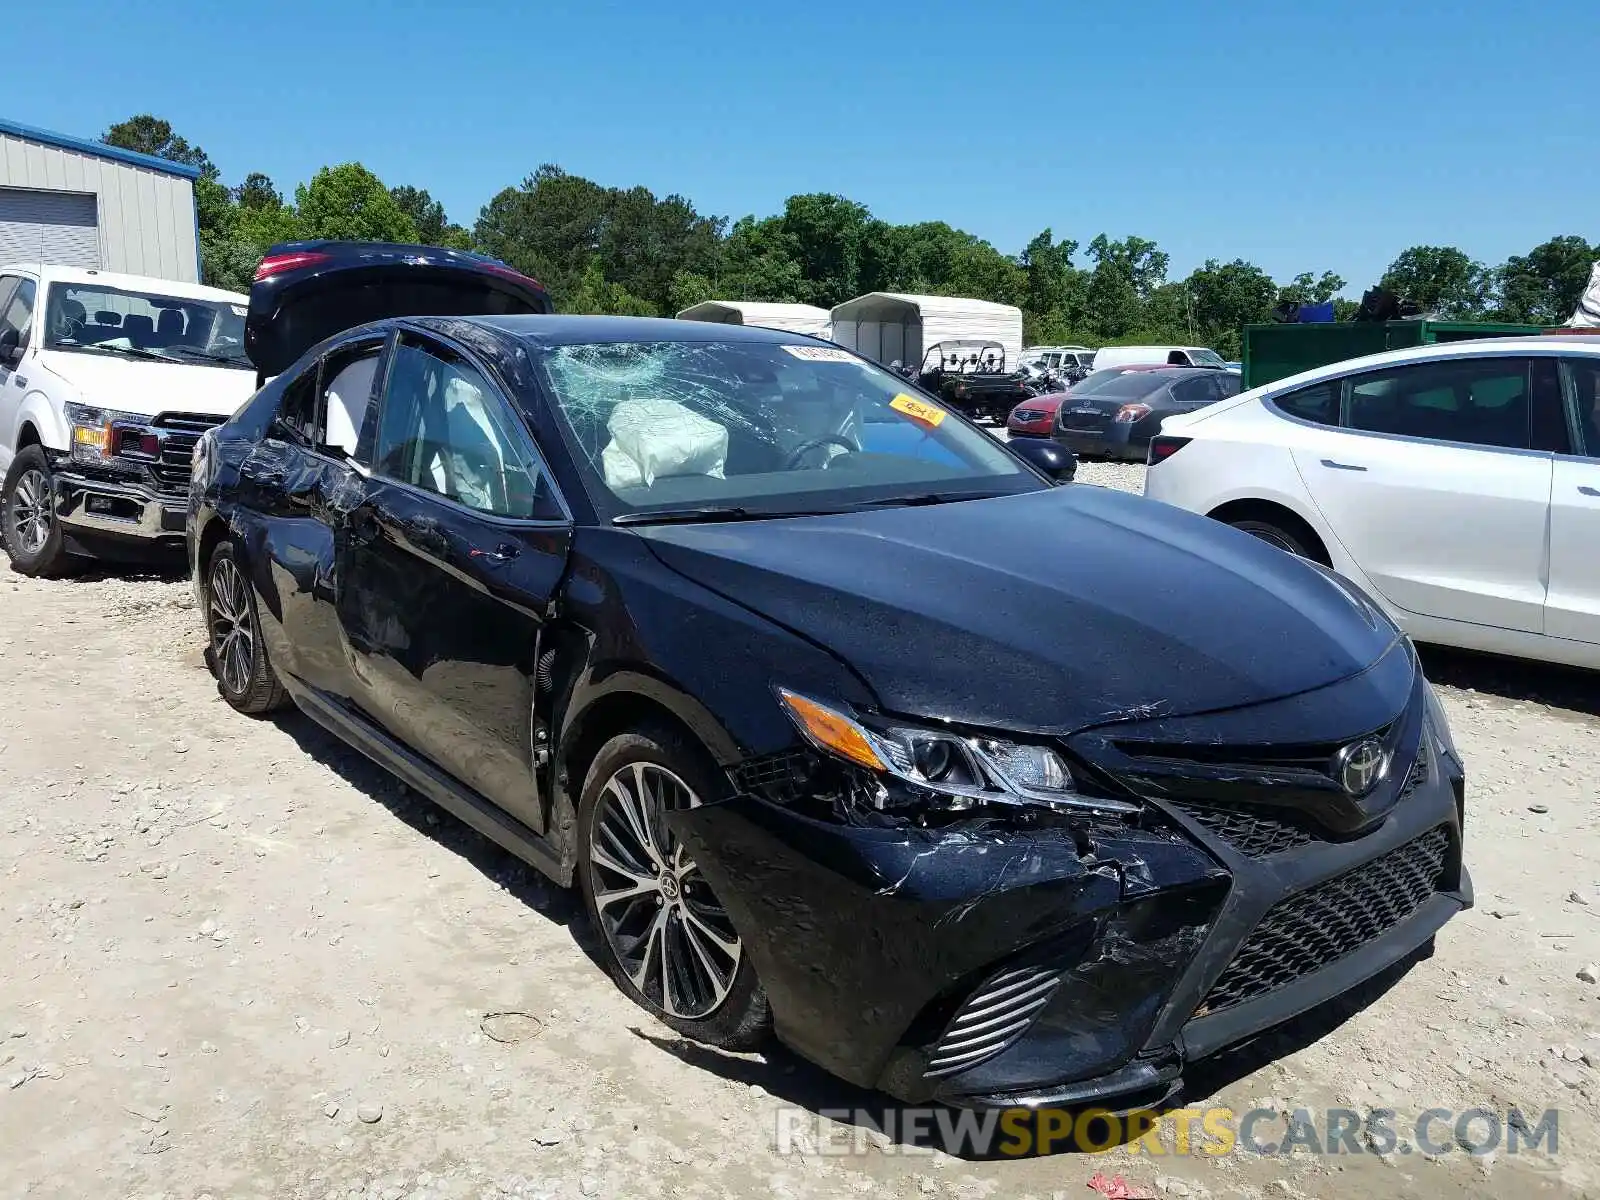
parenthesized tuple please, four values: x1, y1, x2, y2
(187, 245, 1470, 1106)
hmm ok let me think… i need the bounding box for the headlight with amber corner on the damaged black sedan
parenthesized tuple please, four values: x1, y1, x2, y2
(778, 688, 1141, 813)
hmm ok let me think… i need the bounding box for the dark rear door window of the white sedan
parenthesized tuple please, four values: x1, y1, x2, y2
(1346, 358, 1530, 450)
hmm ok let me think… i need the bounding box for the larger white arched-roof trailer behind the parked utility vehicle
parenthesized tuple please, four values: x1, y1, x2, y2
(834, 291, 1022, 370)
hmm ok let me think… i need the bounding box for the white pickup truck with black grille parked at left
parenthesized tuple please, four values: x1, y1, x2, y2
(0, 266, 256, 576)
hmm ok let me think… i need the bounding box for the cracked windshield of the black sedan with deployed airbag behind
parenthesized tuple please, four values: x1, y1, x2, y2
(544, 342, 1043, 518)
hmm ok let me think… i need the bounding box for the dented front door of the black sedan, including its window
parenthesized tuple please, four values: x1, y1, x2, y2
(334, 333, 571, 830)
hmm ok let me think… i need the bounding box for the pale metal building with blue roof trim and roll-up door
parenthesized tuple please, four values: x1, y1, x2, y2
(0, 117, 200, 283)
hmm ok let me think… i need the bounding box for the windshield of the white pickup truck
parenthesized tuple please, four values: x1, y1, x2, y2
(45, 283, 253, 371)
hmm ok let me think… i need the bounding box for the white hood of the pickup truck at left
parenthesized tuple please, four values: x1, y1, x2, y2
(40, 350, 256, 416)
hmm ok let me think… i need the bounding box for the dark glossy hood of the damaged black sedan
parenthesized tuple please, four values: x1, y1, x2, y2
(640, 485, 1398, 734)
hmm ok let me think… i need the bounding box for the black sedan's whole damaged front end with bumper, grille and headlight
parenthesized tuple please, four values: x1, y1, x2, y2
(677, 645, 1470, 1107)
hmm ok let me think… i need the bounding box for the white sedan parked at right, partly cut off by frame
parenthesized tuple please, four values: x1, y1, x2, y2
(1144, 336, 1600, 669)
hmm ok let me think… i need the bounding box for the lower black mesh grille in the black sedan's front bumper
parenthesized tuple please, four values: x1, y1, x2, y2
(1195, 826, 1450, 1016)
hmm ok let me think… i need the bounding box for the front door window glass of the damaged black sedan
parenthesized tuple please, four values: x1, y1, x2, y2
(373, 338, 560, 518)
